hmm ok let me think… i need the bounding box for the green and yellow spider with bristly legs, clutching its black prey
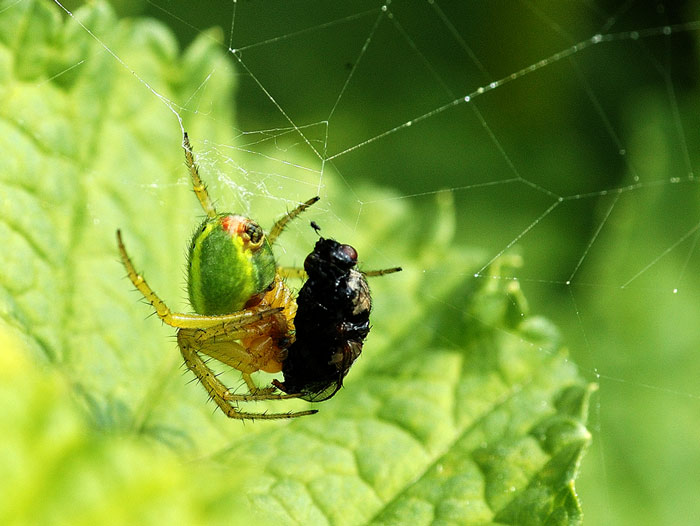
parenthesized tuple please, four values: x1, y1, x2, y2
(117, 133, 319, 419)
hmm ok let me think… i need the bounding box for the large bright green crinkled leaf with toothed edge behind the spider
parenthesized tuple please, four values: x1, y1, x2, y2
(0, 1, 592, 525)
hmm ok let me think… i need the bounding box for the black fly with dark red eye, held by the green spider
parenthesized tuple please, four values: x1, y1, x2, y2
(273, 221, 401, 402)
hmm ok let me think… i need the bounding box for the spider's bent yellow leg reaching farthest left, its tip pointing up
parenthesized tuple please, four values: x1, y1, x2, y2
(117, 230, 282, 329)
